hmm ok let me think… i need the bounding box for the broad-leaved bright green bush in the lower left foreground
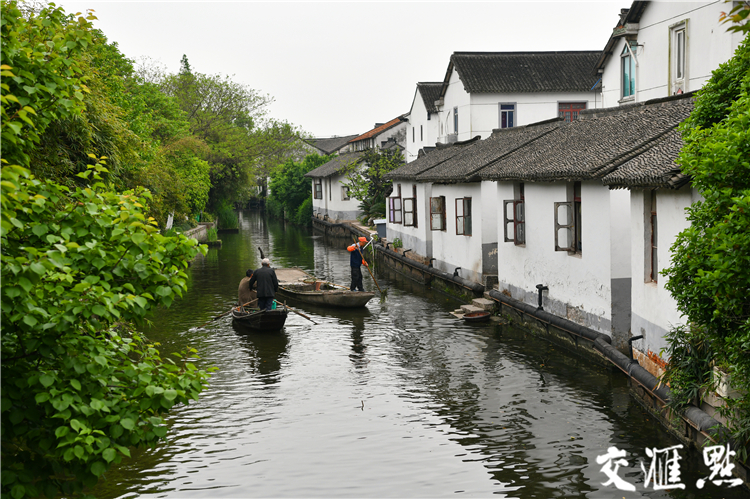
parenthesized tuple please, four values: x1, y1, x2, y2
(0, 165, 213, 499)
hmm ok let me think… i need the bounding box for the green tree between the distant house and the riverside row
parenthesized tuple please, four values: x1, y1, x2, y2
(346, 149, 404, 221)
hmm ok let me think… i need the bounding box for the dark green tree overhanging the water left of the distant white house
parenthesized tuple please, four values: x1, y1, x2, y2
(266, 154, 330, 225)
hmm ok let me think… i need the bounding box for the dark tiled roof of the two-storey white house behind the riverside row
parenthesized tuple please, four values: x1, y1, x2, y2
(451, 50, 601, 93)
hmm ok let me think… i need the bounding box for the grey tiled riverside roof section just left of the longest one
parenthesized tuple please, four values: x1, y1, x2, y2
(416, 118, 564, 183)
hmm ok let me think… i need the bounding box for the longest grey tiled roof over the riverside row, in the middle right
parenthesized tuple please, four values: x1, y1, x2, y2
(479, 94, 693, 181)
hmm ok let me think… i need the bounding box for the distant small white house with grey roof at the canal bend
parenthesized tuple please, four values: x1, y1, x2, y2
(305, 151, 365, 220)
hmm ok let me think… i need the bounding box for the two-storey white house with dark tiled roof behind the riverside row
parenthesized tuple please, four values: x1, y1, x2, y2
(436, 51, 601, 143)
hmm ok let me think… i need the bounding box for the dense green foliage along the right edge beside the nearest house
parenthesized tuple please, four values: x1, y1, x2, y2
(664, 34, 750, 459)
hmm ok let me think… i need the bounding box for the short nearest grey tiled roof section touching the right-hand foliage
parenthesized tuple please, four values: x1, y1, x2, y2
(602, 130, 690, 189)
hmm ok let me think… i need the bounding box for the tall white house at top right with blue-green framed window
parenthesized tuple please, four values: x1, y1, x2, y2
(596, 1, 744, 107)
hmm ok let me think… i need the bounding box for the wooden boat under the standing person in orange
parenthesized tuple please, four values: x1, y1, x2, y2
(274, 267, 375, 308)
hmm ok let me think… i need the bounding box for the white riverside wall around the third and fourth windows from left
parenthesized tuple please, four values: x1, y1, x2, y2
(428, 183, 483, 282)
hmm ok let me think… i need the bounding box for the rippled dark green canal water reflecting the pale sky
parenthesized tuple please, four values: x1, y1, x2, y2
(93, 212, 747, 498)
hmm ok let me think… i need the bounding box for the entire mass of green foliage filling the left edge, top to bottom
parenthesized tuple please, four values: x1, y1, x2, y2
(0, 2, 220, 499)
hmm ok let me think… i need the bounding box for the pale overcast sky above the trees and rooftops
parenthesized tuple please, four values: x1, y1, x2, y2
(55, 0, 631, 137)
